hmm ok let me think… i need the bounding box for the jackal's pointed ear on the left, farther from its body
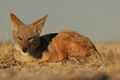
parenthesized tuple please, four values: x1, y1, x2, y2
(10, 13, 24, 29)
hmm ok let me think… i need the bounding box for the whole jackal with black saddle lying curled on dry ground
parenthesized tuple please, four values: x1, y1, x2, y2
(10, 13, 97, 63)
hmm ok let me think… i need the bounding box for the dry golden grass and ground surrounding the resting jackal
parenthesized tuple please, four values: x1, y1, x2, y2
(0, 42, 120, 80)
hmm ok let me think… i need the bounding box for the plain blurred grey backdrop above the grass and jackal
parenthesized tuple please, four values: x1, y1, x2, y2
(0, 0, 120, 42)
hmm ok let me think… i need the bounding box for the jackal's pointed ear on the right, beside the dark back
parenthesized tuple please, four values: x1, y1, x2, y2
(32, 15, 48, 34)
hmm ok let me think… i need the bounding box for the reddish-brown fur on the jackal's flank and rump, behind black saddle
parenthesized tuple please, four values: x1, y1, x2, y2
(43, 31, 97, 61)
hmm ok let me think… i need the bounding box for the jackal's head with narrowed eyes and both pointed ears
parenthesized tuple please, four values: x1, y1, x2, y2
(10, 13, 48, 53)
